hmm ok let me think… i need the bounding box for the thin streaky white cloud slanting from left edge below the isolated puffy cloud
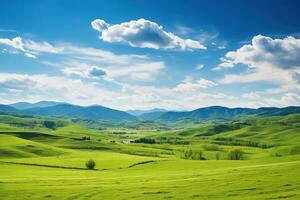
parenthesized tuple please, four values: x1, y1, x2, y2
(0, 36, 165, 81)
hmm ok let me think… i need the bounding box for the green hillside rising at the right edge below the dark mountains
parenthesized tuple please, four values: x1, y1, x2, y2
(176, 114, 300, 146)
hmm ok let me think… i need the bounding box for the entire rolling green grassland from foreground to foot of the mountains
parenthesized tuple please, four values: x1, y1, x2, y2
(0, 115, 300, 200)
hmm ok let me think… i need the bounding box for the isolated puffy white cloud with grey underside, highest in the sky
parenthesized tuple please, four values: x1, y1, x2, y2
(91, 19, 206, 50)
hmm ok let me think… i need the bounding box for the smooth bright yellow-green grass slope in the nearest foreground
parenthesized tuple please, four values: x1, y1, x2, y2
(0, 157, 300, 200)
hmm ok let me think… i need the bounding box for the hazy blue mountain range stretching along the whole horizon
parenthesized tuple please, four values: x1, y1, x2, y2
(0, 101, 300, 122)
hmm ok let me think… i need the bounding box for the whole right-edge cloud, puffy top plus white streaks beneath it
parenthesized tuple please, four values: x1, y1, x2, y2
(217, 35, 300, 93)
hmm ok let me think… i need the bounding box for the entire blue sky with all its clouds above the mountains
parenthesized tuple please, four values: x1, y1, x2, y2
(0, 0, 300, 110)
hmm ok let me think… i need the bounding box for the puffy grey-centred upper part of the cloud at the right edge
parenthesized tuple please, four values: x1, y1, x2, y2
(219, 35, 300, 69)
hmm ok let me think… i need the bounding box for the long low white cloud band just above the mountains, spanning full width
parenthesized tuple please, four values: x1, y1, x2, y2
(0, 73, 300, 110)
